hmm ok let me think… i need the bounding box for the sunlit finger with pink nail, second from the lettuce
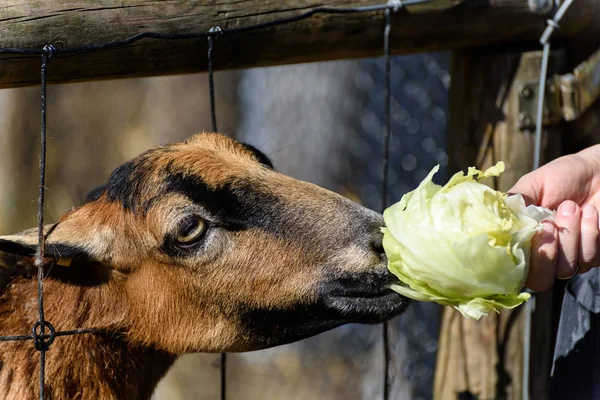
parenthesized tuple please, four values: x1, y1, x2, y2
(555, 200, 581, 279)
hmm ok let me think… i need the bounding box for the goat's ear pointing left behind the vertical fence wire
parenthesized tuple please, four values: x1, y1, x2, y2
(0, 224, 93, 261)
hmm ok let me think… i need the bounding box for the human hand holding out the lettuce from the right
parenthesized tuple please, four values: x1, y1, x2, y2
(509, 145, 600, 291)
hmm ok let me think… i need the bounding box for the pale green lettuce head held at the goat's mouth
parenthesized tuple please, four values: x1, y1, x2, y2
(383, 162, 554, 319)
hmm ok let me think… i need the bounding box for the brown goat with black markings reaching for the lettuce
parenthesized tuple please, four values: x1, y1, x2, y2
(0, 134, 408, 399)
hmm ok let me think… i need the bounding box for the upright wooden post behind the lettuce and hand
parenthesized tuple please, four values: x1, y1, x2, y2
(434, 51, 565, 400)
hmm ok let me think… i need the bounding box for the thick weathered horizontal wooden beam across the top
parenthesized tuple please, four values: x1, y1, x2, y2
(0, 0, 596, 88)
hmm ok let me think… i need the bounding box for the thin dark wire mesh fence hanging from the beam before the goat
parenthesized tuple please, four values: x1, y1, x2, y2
(0, 0, 428, 400)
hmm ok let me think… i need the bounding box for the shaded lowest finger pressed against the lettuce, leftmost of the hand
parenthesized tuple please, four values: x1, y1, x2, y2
(525, 221, 558, 292)
